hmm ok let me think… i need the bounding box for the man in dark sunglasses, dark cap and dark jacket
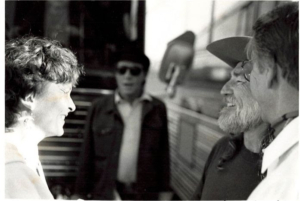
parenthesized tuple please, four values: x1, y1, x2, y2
(76, 50, 170, 200)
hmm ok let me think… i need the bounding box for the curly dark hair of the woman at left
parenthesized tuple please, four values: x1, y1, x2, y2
(5, 36, 84, 128)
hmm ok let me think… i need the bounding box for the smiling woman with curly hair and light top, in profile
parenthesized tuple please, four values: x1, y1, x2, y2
(5, 37, 83, 199)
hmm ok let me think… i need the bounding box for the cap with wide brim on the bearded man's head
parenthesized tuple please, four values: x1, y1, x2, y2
(206, 36, 251, 68)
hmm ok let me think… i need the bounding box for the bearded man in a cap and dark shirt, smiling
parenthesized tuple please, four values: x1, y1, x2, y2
(193, 37, 268, 200)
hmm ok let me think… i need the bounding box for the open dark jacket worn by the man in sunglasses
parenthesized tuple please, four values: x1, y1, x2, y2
(75, 95, 170, 200)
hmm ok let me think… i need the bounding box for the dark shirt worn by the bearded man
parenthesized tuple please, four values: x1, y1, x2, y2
(191, 134, 260, 200)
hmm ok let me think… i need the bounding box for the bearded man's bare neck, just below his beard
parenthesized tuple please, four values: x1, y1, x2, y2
(244, 123, 268, 153)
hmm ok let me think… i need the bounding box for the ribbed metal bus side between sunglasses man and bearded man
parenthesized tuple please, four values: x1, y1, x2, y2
(167, 103, 225, 199)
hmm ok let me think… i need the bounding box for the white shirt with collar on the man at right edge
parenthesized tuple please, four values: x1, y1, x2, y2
(248, 117, 300, 200)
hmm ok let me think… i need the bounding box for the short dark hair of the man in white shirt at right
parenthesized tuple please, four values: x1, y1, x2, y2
(252, 2, 299, 90)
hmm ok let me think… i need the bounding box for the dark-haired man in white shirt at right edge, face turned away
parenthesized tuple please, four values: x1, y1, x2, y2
(248, 2, 300, 200)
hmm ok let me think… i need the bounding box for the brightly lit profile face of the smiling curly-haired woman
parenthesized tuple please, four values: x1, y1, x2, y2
(32, 82, 75, 137)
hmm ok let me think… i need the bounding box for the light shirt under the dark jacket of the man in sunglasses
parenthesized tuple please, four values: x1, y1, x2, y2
(115, 93, 152, 183)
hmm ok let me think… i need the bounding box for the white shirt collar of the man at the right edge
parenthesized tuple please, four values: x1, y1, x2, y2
(261, 117, 299, 172)
